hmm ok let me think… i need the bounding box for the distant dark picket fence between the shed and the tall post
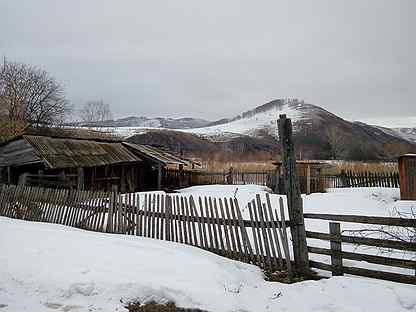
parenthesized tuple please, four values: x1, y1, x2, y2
(162, 168, 276, 189)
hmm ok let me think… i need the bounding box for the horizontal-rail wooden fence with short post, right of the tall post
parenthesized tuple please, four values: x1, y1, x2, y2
(304, 213, 416, 284)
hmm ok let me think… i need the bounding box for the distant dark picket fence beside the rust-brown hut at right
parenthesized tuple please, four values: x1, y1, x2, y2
(324, 171, 400, 188)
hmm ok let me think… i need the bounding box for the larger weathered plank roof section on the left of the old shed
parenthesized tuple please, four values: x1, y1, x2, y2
(23, 135, 141, 169)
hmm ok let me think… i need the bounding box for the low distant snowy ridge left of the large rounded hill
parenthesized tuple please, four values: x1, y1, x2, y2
(67, 116, 211, 129)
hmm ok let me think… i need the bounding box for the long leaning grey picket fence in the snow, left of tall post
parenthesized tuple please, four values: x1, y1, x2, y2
(0, 185, 292, 276)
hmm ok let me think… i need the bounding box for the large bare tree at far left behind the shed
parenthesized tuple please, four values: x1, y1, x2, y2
(0, 59, 70, 136)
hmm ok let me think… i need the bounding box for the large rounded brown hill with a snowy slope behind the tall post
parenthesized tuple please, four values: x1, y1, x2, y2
(129, 99, 416, 160)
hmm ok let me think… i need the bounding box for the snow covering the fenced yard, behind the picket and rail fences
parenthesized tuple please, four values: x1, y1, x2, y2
(177, 185, 416, 276)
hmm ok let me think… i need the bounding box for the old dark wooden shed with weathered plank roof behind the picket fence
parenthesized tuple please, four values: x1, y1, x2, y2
(0, 134, 192, 192)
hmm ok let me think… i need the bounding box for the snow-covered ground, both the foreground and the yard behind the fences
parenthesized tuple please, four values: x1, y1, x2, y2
(0, 185, 416, 312)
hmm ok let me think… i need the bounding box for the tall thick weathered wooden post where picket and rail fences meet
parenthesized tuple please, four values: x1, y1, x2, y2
(279, 115, 309, 276)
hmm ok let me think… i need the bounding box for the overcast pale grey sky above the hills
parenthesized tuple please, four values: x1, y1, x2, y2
(0, 0, 416, 126)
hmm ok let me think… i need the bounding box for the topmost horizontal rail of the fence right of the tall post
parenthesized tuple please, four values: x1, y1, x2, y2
(303, 213, 416, 227)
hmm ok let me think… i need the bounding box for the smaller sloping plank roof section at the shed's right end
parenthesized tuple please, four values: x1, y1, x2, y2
(123, 142, 190, 165)
